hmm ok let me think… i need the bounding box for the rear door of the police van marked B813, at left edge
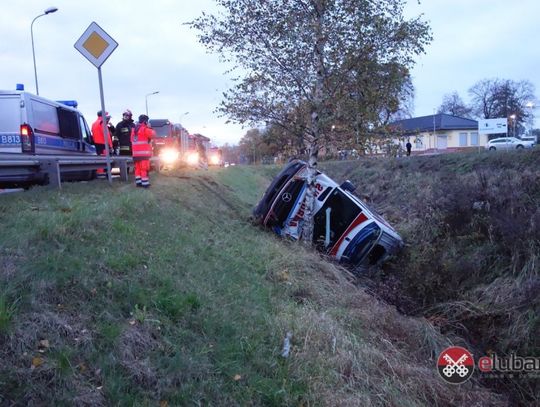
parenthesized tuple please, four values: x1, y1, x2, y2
(0, 94, 22, 154)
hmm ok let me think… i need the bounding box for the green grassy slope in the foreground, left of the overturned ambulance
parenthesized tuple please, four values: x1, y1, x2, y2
(0, 167, 505, 406)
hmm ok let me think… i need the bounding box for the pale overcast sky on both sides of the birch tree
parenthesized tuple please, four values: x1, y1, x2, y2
(0, 0, 540, 145)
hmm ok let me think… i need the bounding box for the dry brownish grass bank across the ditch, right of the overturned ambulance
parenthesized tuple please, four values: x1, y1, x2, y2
(322, 149, 540, 402)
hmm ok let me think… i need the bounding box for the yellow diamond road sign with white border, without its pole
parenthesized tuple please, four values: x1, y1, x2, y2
(75, 22, 118, 68)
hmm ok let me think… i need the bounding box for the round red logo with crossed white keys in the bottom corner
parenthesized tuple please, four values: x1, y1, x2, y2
(437, 346, 474, 384)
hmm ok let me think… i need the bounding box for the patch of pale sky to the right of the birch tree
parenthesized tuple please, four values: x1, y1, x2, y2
(406, 0, 540, 127)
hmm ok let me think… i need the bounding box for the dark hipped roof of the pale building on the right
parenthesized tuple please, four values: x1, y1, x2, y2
(392, 113, 478, 133)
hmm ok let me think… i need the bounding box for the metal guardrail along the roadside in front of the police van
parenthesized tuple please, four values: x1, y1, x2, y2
(0, 153, 143, 188)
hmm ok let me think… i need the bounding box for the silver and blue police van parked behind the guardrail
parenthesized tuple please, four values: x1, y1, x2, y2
(0, 85, 96, 155)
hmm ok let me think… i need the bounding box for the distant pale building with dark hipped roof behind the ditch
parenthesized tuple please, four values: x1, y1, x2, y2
(391, 113, 488, 154)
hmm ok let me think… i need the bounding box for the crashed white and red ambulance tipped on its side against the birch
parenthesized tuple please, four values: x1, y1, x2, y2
(253, 160, 403, 266)
